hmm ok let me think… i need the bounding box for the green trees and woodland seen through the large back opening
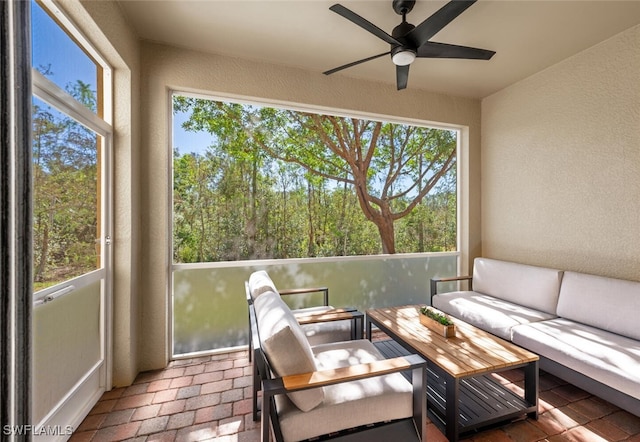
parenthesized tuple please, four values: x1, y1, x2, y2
(173, 97, 456, 262)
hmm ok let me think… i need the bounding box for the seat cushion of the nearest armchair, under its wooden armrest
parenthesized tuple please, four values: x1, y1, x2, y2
(276, 339, 413, 442)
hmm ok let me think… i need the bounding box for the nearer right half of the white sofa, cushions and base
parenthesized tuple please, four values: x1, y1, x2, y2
(513, 271, 640, 410)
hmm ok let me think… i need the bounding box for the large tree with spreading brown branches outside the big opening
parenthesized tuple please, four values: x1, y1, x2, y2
(174, 97, 456, 254)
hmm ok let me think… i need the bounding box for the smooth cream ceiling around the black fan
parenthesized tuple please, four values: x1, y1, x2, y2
(119, 0, 640, 98)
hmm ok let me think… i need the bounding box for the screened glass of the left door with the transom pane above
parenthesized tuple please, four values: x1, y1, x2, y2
(31, 2, 111, 292)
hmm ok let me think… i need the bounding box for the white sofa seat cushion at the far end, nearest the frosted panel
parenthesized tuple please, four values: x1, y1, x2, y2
(432, 291, 556, 341)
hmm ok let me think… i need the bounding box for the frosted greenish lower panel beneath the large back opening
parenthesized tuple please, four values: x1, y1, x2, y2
(173, 253, 458, 356)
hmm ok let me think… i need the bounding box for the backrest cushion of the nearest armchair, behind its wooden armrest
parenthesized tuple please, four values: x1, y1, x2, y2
(254, 291, 324, 411)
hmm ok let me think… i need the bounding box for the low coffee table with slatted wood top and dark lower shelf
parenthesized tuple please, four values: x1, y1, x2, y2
(365, 305, 539, 441)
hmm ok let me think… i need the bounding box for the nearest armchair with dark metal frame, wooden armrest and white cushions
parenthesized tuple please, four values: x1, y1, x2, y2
(249, 291, 426, 442)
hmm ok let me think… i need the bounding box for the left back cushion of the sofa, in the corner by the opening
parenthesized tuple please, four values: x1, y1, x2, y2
(473, 258, 562, 315)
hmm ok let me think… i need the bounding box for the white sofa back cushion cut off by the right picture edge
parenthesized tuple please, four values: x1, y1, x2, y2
(558, 272, 640, 339)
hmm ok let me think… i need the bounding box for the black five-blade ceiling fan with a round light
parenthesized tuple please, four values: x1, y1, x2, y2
(323, 0, 495, 90)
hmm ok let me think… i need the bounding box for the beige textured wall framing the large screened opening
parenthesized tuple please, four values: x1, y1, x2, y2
(140, 43, 480, 369)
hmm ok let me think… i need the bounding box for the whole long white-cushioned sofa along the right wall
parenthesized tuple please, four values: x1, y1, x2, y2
(431, 258, 640, 416)
